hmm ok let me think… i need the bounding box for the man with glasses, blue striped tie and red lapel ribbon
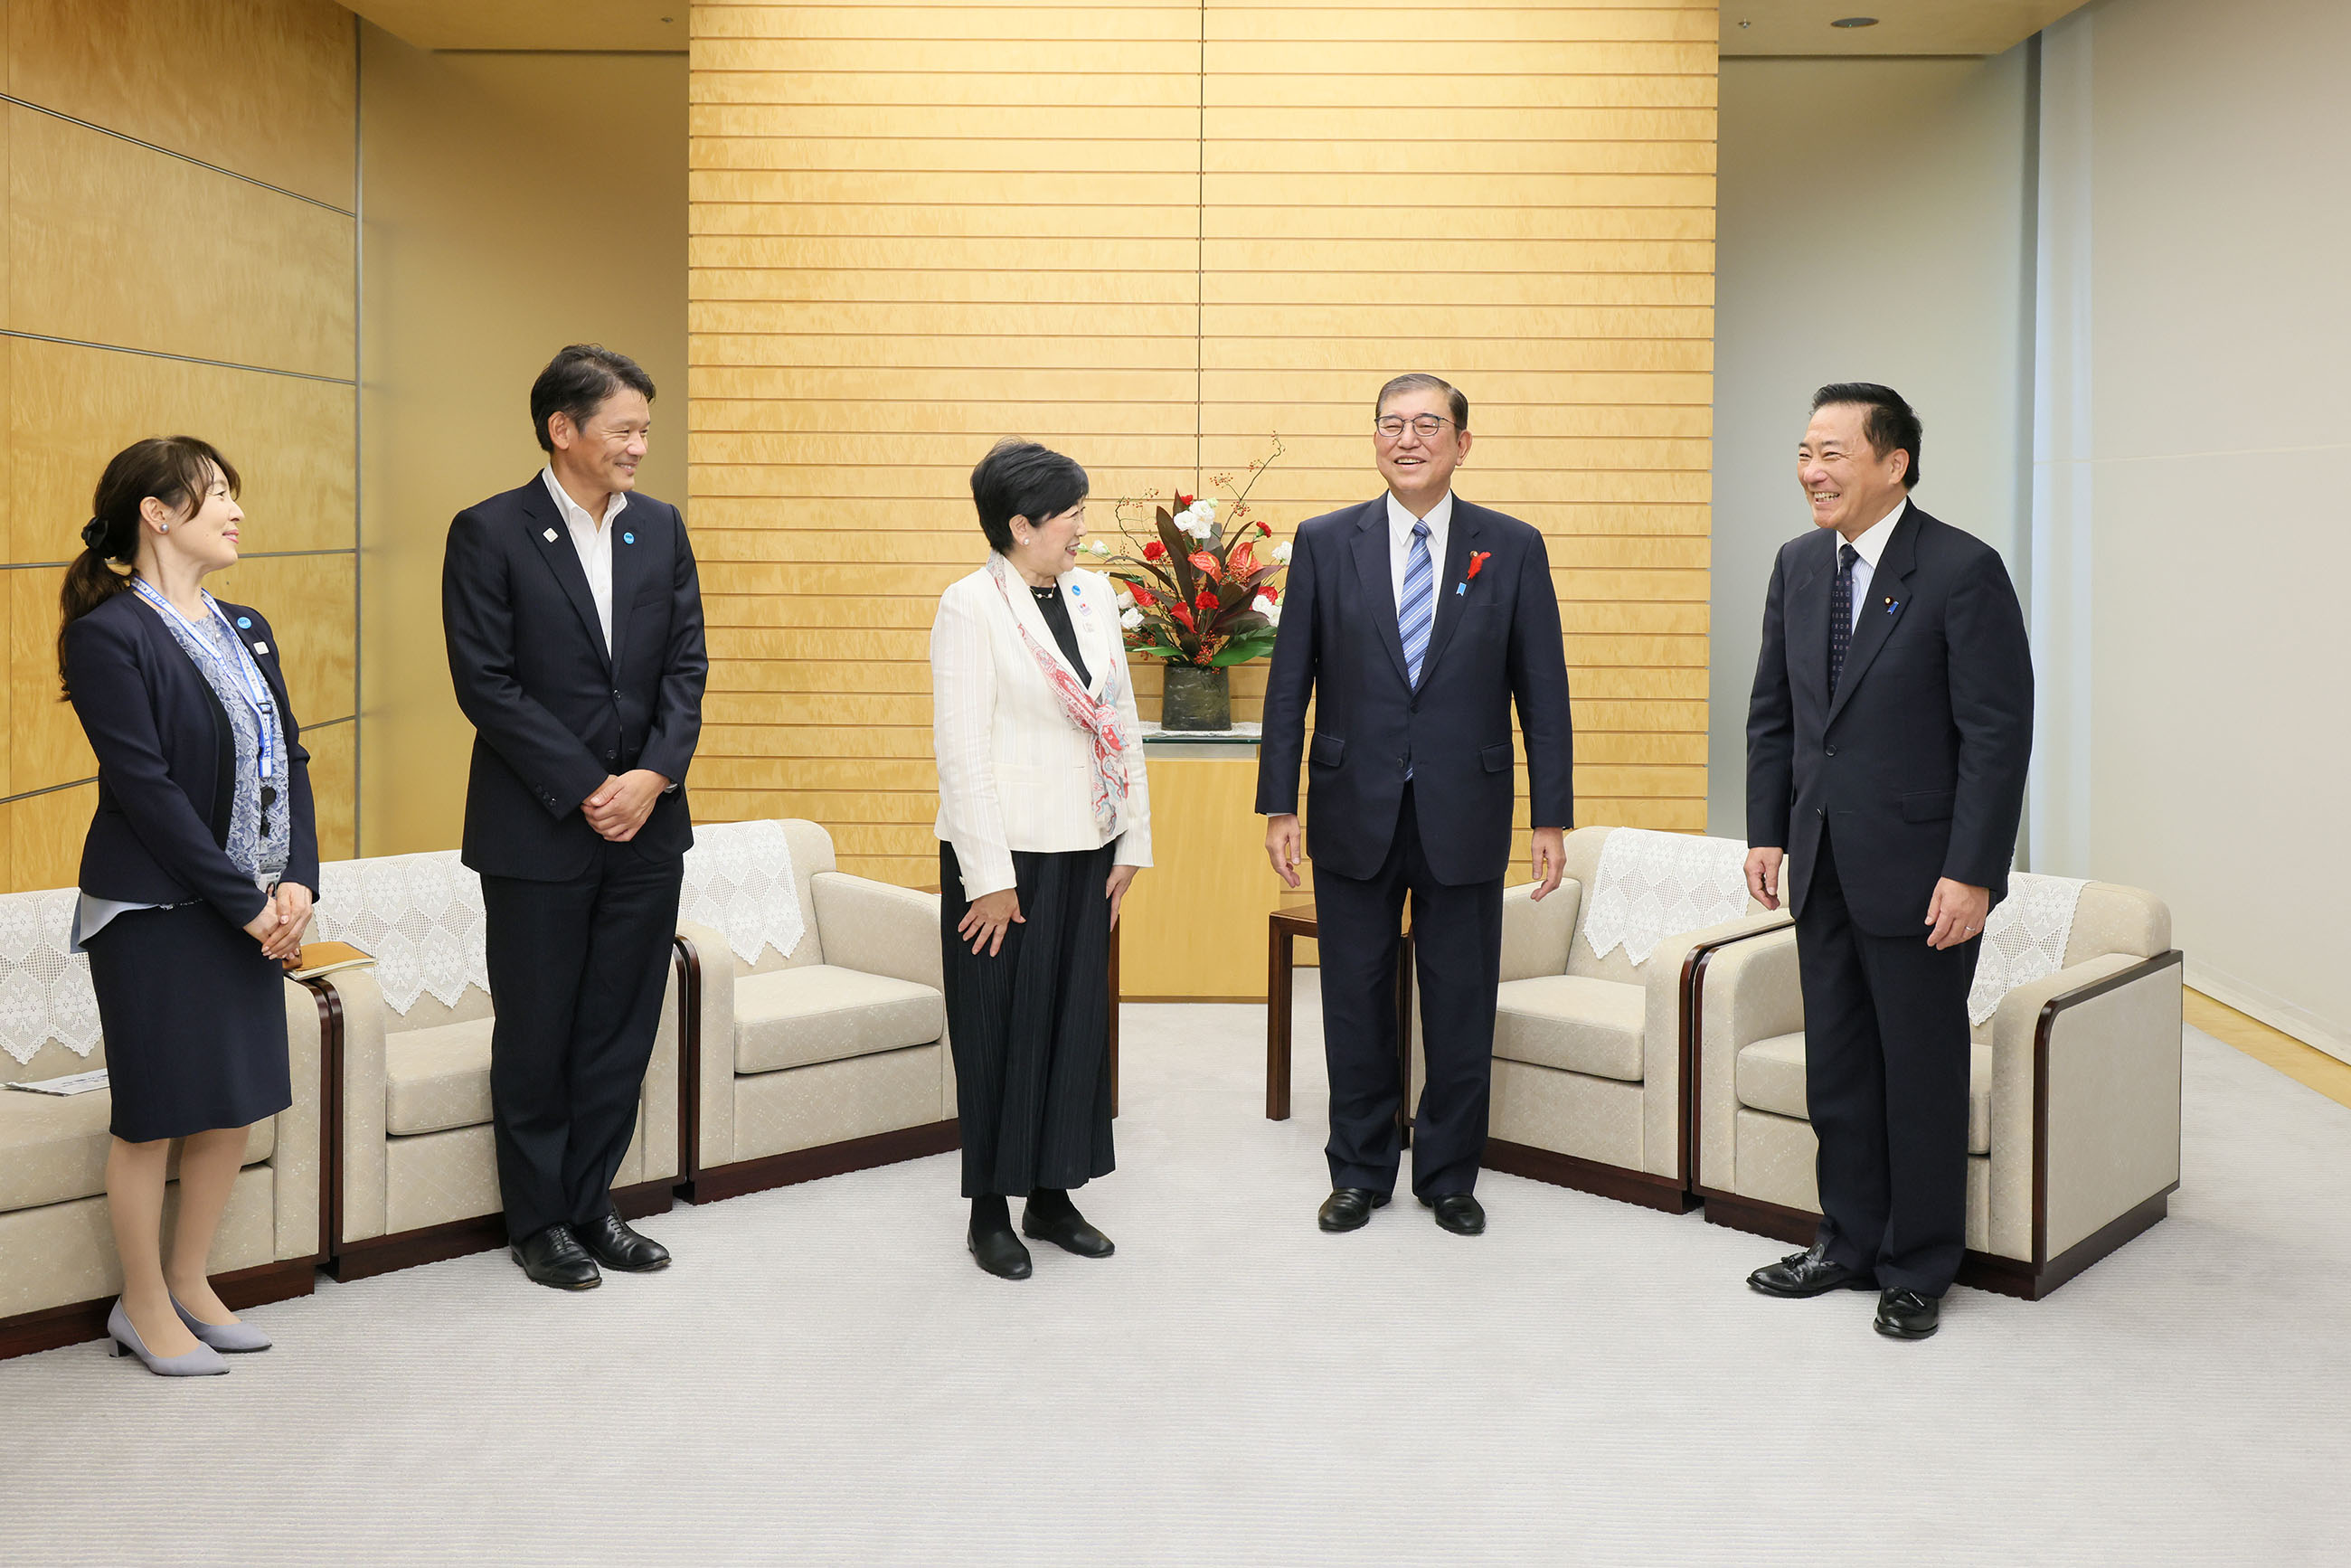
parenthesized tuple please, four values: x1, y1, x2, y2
(1258, 376, 1575, 1236)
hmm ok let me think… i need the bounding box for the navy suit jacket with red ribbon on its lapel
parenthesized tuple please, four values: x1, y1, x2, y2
(1258, 494, 1575, 886)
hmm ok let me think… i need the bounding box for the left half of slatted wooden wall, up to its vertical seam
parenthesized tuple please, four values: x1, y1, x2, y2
(689, 5, 1199, 883)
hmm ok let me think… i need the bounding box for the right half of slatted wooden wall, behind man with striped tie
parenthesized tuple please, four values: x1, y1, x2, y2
(1202, 0, 1716, 865)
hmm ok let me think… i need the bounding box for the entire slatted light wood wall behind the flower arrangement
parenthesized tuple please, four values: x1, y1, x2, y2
(689, 0, 1716, 883)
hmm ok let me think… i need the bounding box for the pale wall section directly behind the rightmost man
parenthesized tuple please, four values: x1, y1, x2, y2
(1707, 47, 2031, 836)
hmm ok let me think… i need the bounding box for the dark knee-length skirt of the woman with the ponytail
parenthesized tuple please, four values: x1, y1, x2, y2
(85, 902, 294, 1142)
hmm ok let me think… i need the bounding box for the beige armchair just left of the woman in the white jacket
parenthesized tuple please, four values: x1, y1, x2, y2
(677, 820, 957, 1204)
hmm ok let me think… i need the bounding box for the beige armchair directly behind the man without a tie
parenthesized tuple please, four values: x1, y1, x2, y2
(313, 851, 685, 1279)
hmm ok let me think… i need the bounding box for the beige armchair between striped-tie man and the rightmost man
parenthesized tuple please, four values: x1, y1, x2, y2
(1448, 827, 1787, 1213)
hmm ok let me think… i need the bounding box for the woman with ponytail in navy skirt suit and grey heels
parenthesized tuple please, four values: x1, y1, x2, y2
(56, 435, 317, 1375)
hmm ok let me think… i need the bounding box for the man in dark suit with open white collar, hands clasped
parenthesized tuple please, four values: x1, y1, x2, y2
(442, 344, 710, 1290)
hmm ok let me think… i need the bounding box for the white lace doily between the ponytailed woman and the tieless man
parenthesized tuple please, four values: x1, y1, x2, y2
(310, 848, 489, 1013)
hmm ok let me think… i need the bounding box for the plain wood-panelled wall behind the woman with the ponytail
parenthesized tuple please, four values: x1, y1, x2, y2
(0, 0, 357, 889)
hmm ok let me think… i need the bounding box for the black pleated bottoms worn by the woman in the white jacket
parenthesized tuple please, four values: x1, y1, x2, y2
(938, 844, 1117, 1199)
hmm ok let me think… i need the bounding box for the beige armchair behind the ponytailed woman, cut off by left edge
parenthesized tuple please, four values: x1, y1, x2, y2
(0, 889, 325, 1356)
